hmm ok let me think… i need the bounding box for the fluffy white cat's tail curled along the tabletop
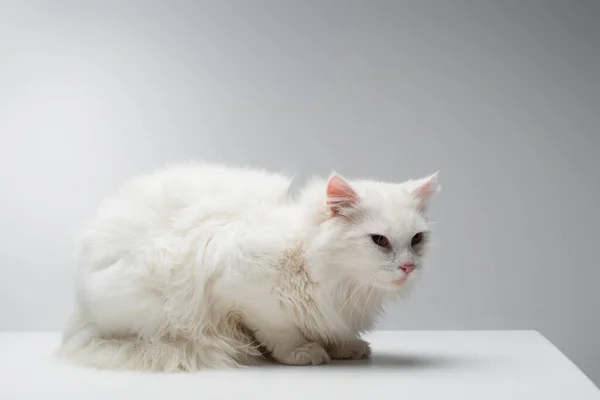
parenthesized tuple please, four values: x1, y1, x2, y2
(55, 314, 264, 372)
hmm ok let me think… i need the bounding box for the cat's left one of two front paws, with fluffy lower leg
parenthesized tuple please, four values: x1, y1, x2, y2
(249, 321, 330, 365)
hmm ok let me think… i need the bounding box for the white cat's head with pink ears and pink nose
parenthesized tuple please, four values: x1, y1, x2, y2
(309, 173, 440, 292)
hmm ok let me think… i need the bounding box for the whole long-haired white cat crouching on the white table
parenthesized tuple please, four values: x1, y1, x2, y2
(59, 164, 439, 371)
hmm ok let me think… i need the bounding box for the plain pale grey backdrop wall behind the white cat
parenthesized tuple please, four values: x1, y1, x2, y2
(0, 0, 600, 383)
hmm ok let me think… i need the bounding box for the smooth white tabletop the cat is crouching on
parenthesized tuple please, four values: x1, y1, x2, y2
(0, 331, 600, 400)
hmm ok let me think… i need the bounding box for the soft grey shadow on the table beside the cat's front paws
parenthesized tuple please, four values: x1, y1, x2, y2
(329, 353, 475, 370)
